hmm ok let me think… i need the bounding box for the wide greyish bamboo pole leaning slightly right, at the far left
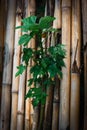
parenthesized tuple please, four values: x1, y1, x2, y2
(1, 0, 16, 130)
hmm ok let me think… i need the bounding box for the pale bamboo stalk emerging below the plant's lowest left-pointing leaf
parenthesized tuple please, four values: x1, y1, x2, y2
(17, 60, 26, 130)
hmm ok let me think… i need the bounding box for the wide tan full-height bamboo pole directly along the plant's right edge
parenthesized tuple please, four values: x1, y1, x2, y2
(59, 0, 71, 130)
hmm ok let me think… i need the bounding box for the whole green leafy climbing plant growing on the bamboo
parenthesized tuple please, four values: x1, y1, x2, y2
(16, 16, 66, 107)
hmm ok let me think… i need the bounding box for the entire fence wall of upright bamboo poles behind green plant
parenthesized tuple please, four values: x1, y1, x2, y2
(0, 0, 87, 130)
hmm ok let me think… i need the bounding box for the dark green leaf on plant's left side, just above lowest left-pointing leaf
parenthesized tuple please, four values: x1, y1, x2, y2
(22, 48, 33, 65)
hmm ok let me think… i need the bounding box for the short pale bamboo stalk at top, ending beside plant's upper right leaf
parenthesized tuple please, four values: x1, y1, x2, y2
(53, 0, 62, 29)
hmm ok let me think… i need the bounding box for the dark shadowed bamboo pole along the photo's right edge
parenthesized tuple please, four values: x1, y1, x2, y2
(82, 0, 87, 130)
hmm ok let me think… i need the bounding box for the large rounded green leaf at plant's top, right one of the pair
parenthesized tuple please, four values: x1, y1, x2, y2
(39, 16, 55, 29)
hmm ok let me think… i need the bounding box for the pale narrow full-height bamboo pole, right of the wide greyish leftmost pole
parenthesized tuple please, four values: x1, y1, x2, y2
(11, 0, 22, 130)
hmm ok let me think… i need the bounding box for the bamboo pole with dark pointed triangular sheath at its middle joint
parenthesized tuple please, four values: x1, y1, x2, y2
(70, 0, 81, 130)
